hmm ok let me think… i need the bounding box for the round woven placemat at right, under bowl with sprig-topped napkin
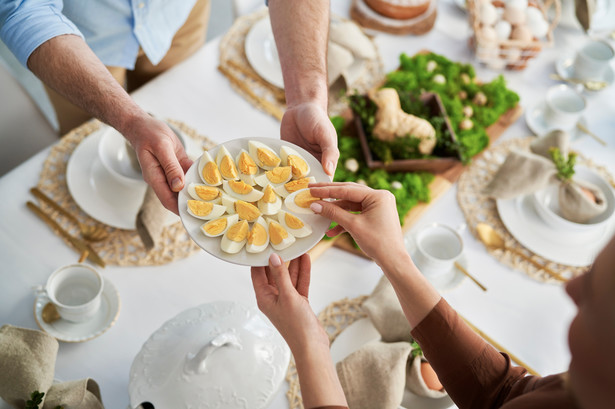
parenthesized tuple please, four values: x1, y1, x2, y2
(457, 137, 613, 282)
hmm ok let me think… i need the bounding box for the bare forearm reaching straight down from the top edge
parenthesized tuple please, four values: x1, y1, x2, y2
(269, 0, 329, 108)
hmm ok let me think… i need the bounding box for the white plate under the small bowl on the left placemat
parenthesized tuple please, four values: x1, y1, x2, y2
(66, 128, 147, 230)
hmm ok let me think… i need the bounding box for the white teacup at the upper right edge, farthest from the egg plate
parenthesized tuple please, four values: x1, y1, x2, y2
(574, 40, 615, 81)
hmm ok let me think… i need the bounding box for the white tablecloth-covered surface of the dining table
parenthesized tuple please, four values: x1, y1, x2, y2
(0, 0, 615, 409)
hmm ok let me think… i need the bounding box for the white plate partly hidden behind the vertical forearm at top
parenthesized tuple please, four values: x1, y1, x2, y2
(244, 16, 284, 89)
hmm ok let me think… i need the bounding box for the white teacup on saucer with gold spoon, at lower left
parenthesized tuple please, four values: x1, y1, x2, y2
(45, 264, 104, 322)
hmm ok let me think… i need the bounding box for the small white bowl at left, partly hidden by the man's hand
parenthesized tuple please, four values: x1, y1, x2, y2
(98, 127, 145, 187)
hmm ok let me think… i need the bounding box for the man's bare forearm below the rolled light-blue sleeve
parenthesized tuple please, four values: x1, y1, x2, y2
(28, 35, 145, 133)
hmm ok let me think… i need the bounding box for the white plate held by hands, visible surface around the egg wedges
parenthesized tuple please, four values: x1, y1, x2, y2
(178, 138, 331, 266)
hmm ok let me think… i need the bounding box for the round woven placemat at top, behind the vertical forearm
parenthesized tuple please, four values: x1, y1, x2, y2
(218, 9, 384, 120)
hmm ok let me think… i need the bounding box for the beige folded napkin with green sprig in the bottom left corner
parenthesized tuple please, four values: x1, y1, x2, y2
(0, 325, 103, 409)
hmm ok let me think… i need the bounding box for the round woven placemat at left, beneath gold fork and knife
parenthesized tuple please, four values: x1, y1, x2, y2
(37, 120, 215, 266)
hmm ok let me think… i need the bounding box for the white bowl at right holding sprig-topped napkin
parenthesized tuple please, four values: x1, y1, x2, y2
(534, 167, 615, 233)
